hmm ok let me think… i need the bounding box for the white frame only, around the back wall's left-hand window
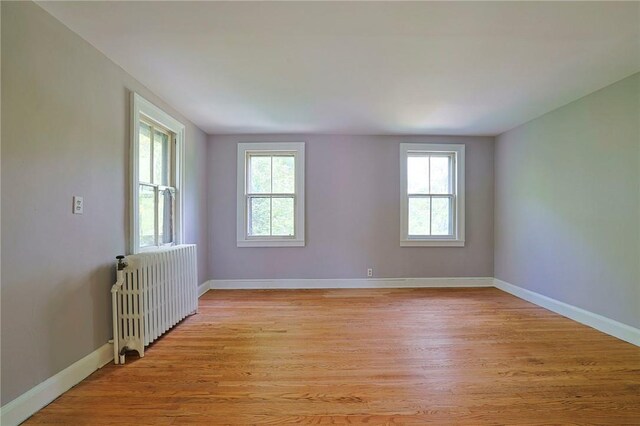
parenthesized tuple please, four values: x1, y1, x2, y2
(236, 142, 305, 247)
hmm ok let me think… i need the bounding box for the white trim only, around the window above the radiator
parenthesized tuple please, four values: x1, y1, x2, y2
(129, 92, 185, 254)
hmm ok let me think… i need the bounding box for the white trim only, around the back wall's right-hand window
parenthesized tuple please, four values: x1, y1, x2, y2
(400, 143, 465, 247)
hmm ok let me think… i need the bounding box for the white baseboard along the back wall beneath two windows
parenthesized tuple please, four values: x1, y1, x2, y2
(208, 277, 493, 290)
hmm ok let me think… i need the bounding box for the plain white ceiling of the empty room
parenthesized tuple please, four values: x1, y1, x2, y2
(39, 1, 640, 135)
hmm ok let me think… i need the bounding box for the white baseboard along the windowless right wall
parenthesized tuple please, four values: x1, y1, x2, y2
(494, 278, 640, 346)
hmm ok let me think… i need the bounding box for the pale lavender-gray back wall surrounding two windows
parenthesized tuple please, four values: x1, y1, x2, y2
(208, 135, 493, 279)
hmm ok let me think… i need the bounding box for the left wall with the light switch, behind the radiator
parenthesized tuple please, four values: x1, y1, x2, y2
(1, 2, 208, 405)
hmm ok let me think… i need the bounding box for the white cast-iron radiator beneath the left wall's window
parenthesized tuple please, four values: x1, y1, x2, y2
(111, 244, 198, 364)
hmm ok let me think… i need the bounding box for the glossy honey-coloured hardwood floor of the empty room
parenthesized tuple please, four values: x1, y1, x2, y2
(27, 288, 640, 425)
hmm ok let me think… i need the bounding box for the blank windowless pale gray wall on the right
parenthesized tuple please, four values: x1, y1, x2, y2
(495, 74, 640, 327)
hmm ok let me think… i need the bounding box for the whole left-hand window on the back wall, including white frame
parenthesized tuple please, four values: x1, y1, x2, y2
(237, 143, 304, 247)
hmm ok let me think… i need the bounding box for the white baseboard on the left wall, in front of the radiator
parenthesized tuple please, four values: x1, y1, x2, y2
(0, 343, 113, 426)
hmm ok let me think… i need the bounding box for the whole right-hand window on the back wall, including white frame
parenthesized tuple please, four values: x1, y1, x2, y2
(400, 144, 464, 246)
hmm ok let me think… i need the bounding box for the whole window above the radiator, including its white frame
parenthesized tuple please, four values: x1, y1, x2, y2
(131, 93, 184, 253)
